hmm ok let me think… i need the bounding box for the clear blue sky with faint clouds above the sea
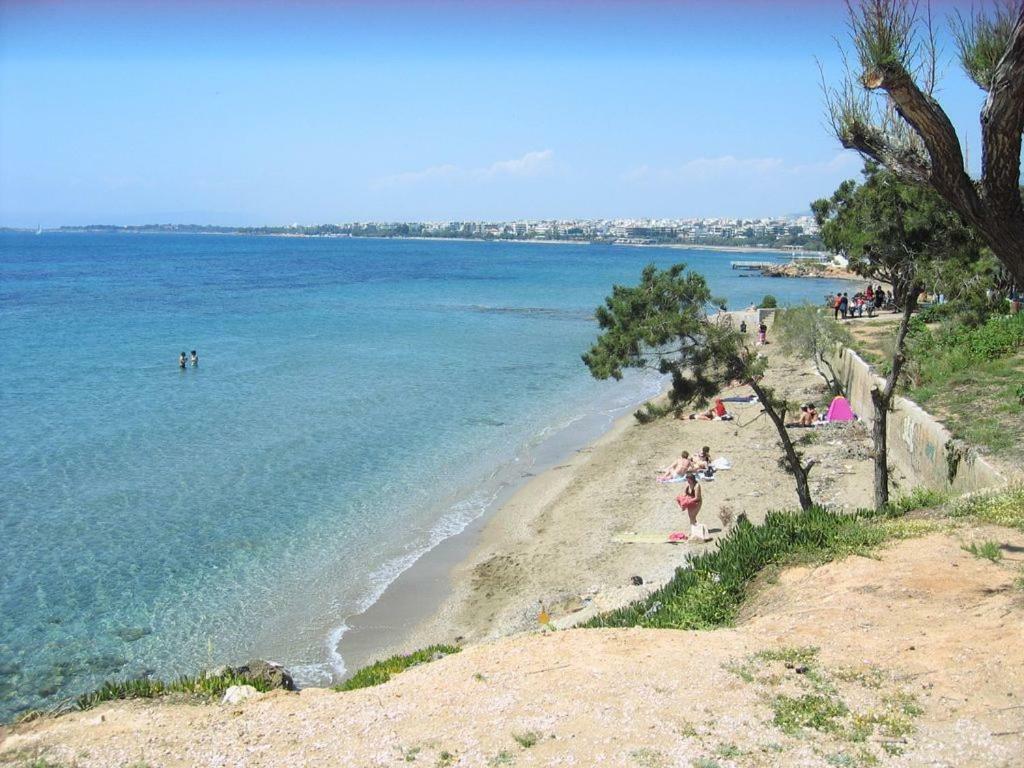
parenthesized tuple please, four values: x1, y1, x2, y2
(0, 0, 982, 226)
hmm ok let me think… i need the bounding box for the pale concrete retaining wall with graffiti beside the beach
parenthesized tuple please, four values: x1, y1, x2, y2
(831, 349, 1007, 493)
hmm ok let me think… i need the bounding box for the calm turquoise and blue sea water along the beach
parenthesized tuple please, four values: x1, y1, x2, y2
(0, 233, 851, 720)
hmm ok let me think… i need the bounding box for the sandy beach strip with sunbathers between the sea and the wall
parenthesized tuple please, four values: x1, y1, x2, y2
(341, 337, 888, 670)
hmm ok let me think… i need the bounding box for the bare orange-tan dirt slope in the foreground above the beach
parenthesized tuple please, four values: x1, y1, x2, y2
(0, 528, 1024, 768)
